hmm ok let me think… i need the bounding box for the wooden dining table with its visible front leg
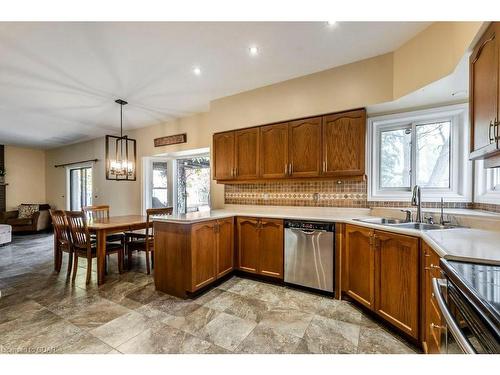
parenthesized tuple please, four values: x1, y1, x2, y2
(87, 215, 148, 285)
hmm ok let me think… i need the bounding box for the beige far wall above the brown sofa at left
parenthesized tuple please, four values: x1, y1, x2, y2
(5, 146, 46, 211)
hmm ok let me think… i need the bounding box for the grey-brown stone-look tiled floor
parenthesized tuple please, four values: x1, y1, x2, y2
(0, 235, 415, 354)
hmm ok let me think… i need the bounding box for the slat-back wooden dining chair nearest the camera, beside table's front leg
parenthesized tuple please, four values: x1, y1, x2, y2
(65, 211, 124, 284)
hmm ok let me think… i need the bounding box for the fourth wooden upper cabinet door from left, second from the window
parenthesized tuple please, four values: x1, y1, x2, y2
(288, 117, 321, 177)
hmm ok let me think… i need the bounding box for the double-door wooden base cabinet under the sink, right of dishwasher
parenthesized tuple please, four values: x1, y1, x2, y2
(342, 224, 420, 338)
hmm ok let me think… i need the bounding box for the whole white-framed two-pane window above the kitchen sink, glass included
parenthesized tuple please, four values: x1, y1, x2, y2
(367, 104, 471, 201)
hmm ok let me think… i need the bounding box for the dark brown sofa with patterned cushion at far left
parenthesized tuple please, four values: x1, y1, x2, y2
(3, 203, 50, 233)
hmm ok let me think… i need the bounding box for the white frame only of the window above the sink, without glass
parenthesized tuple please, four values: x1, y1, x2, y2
(366, 103, 472, 202)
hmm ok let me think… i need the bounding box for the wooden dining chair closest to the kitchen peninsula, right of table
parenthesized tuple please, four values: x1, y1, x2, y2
(125, 207, 173, 275)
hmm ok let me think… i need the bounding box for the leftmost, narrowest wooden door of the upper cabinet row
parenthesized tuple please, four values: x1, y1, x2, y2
(213, 132, 235, 180)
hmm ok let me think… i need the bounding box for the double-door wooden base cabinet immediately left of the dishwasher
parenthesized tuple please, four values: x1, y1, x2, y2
(237, 217, 284, 279)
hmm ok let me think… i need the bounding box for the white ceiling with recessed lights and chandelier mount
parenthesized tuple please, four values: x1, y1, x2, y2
(0, 22, 429, 148)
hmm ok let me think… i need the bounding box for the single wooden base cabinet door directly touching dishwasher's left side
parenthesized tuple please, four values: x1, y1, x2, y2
(259, 219, 284, 279)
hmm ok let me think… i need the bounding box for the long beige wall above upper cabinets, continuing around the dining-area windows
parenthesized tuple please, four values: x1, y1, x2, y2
(47, 23, 480, 215)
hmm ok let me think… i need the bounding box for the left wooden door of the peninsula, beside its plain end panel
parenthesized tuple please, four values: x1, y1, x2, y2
(190, 221, 217, 292)
